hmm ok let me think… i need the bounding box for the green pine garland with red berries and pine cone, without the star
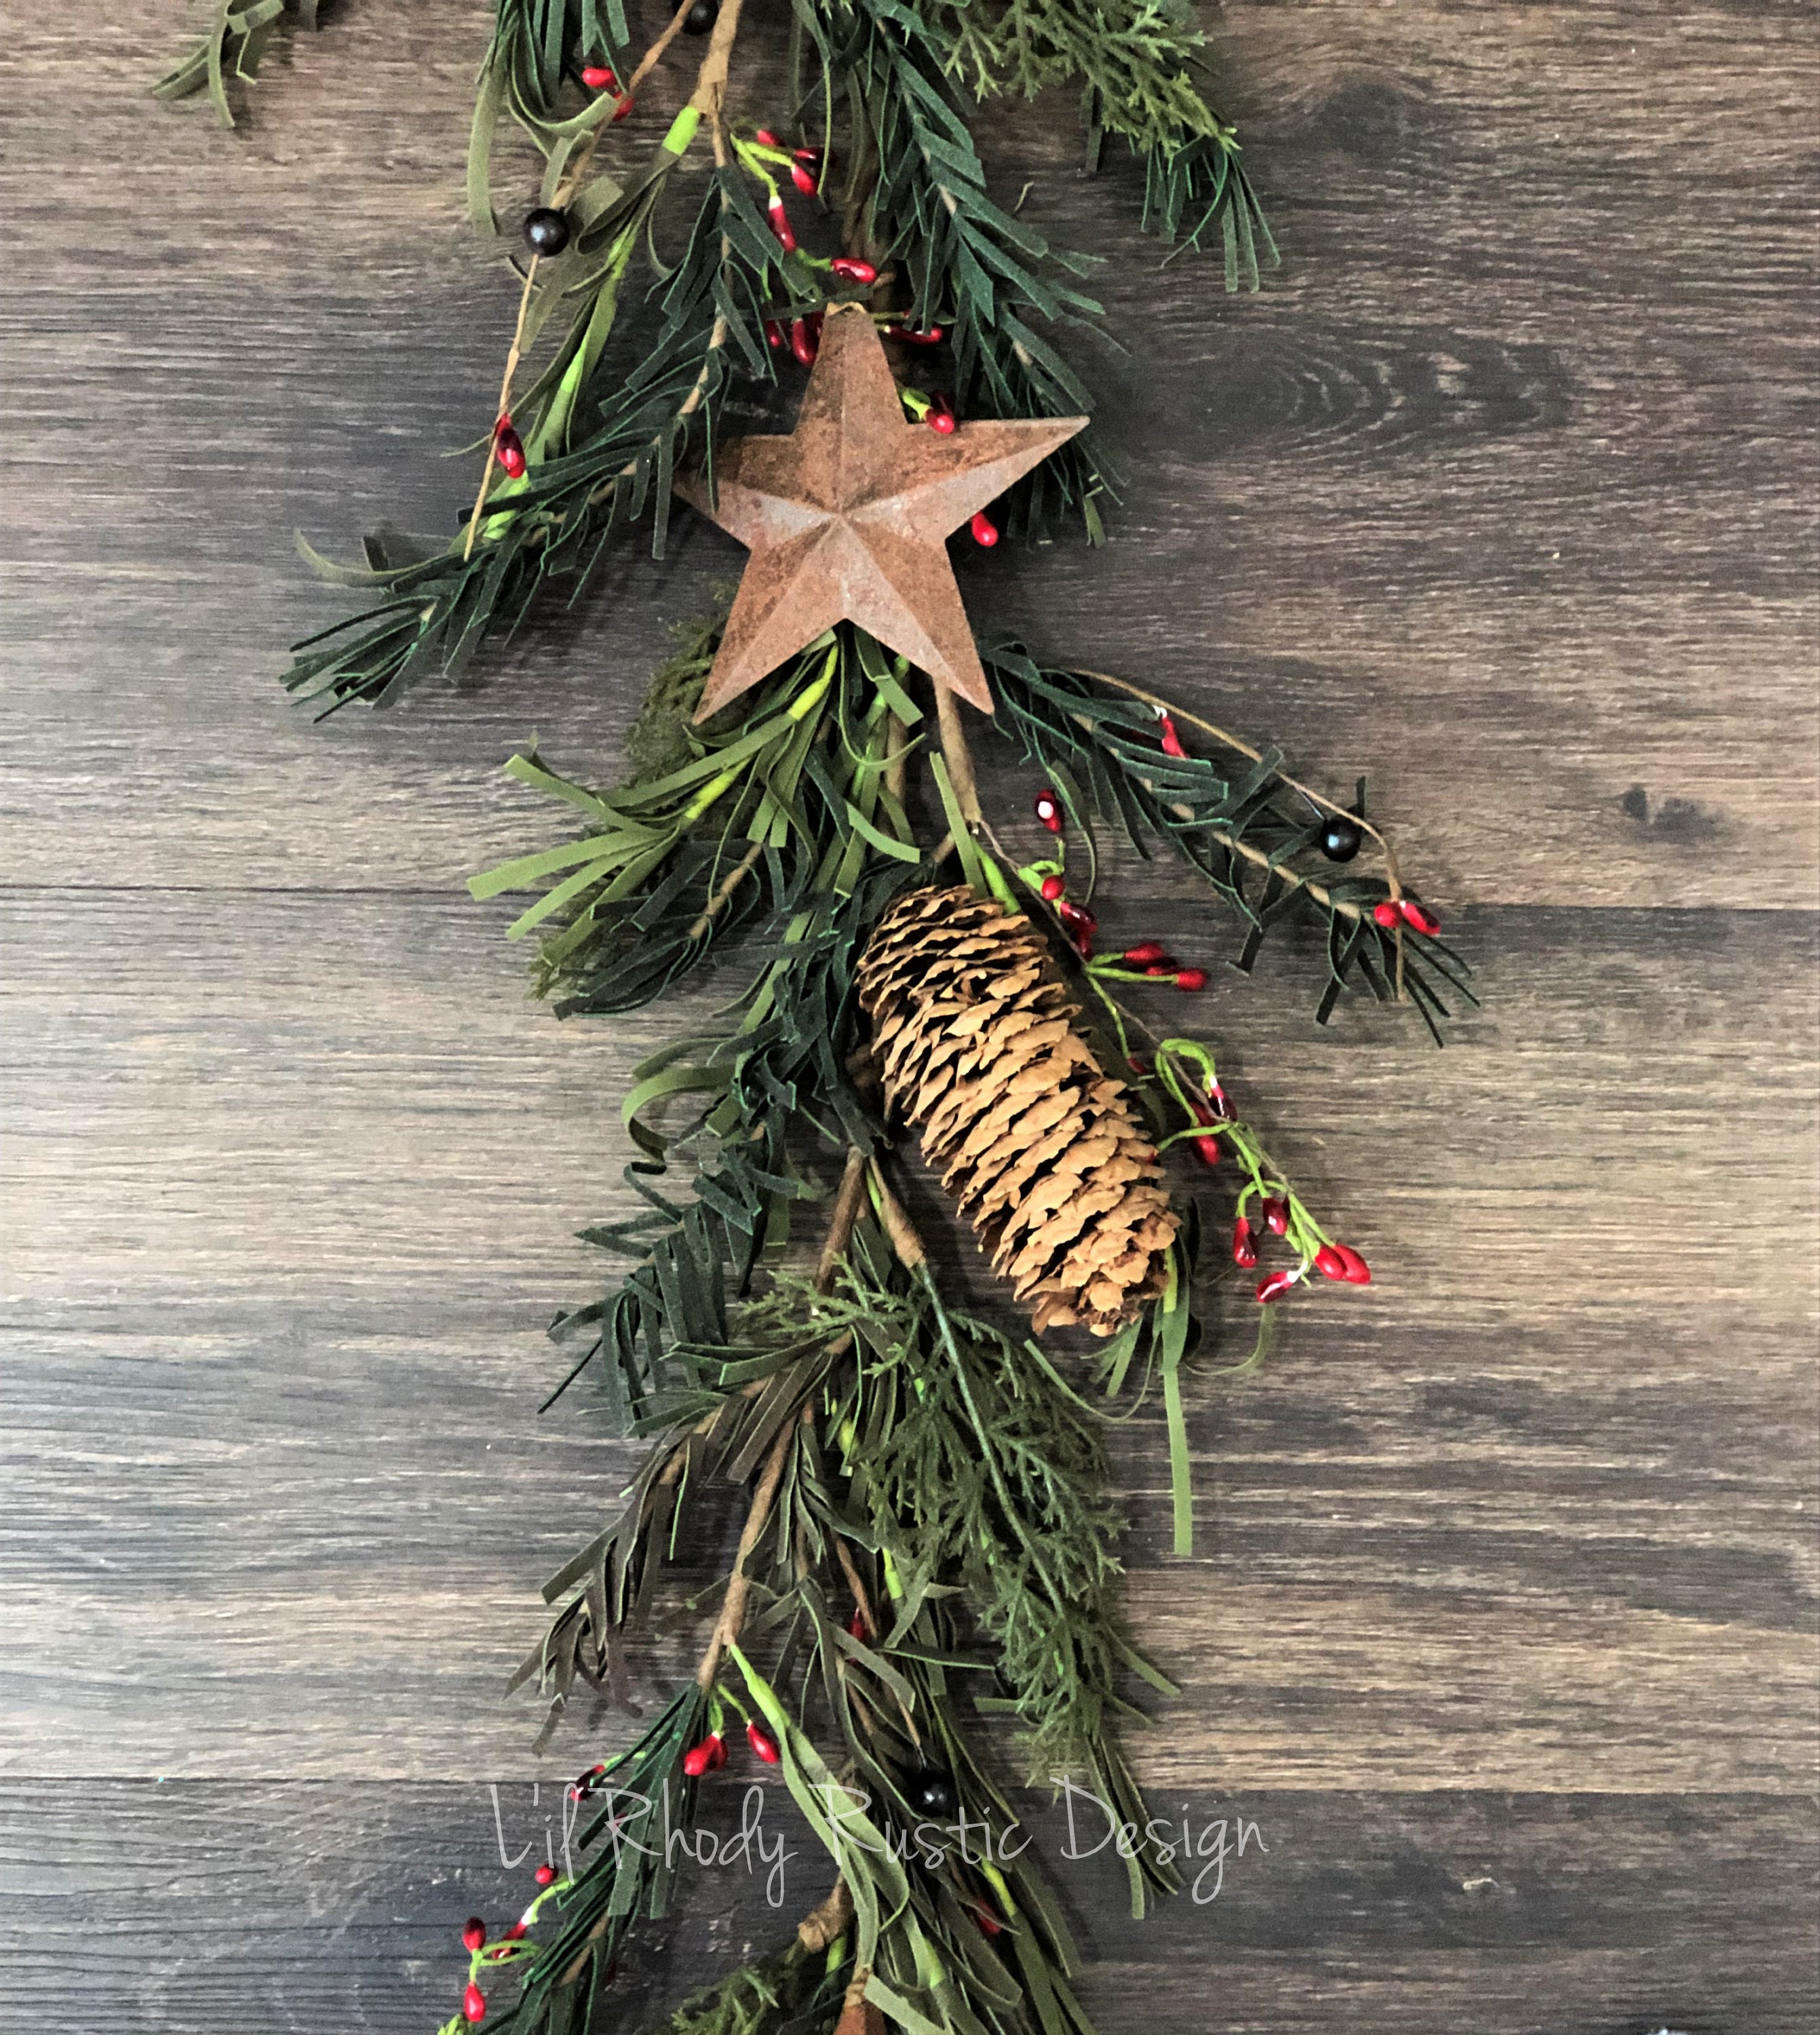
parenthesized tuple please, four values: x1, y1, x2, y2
(157, 0, 1470, 2035)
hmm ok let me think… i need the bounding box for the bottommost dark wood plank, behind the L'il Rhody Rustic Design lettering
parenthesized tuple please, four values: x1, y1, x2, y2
(0, 1777, 1820, 2035)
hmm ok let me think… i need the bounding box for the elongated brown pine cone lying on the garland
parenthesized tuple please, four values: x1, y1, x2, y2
(857, 887, 1177, 1335)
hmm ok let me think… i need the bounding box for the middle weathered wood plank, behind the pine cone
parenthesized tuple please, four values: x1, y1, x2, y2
(6, 899, 1814, 1791)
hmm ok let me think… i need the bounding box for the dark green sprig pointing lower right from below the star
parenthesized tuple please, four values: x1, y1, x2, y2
(982, 643, 1478, 1044)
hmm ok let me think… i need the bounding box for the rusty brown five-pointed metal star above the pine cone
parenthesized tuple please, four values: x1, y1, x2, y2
(676, 303, 1087, 720)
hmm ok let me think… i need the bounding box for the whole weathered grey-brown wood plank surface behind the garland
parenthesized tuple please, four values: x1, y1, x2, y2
(0, 0, 1820, 2035)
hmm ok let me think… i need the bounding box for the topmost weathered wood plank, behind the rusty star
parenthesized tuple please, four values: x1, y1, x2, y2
(0, 6, 1816, 906)
